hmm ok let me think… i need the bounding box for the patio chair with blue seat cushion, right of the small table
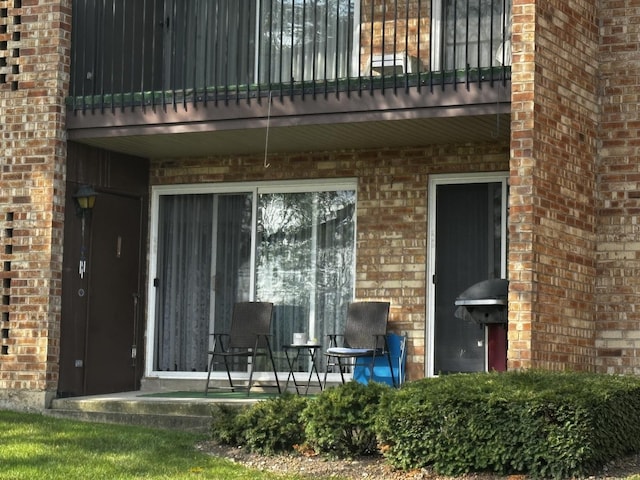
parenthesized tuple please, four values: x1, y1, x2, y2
(324, 302, 397, 387)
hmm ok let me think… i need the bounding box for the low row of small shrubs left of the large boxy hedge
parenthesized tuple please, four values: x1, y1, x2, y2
(211, 382, 391, 457)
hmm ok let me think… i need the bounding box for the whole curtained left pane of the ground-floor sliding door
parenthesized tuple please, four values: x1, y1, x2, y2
(155, 193, 253, 371)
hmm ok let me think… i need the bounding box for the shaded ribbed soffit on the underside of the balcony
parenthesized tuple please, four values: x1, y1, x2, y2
(70, 114, 510, 158)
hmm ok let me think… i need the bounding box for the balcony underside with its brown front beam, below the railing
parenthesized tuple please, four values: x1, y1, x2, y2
(67, 82, 511, 158)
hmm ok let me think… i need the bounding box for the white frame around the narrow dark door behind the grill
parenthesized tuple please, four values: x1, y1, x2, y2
(424, 172, 509, 377)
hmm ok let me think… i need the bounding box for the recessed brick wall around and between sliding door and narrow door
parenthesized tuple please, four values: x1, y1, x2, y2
(151, 145, 508, 379)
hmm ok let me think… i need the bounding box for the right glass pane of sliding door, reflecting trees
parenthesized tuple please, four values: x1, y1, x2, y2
(256, 191, 355, 370)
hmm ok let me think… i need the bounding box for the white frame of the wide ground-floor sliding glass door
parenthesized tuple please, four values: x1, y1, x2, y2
(144, 178, 358, 382)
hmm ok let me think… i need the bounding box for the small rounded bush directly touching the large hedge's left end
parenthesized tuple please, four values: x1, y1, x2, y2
(302, 382, 391, 457)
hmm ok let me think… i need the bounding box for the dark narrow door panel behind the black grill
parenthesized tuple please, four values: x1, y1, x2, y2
(434, 183, 500, 374)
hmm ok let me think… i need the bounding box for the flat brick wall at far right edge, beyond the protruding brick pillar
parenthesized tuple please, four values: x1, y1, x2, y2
(596, 0, 640, 375)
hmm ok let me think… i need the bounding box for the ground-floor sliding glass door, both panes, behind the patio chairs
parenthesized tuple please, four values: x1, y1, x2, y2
(147, 182, 356, 374)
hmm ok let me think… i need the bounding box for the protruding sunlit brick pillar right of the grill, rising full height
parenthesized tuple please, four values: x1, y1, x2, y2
(509, 0, 598, 370)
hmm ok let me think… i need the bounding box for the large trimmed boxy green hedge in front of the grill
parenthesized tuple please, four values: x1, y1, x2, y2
(376, 371, 640, 478)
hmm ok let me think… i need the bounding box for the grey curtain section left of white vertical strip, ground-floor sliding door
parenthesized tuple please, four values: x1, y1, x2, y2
(153, 195, 213, 371)
